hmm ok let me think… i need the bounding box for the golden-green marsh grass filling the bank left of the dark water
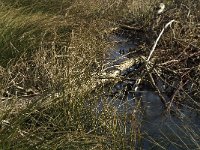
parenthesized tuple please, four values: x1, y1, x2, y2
(0, 0, 141, 149)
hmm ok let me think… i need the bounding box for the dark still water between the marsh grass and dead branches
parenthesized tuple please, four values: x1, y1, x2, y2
(101, 36, 200, 150)
